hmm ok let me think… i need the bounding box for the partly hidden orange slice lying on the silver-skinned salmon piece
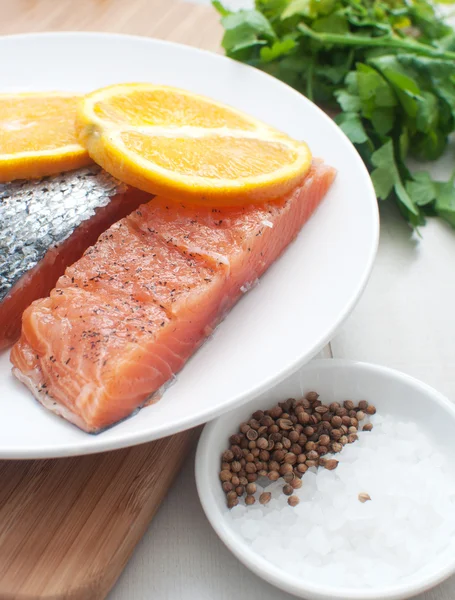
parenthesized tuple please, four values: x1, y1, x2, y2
(0, 92, 92, 181)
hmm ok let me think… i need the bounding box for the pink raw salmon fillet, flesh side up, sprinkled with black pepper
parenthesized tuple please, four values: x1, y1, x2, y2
(11, 161, 335, 432)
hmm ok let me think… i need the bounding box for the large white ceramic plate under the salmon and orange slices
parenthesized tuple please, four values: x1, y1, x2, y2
(0, 33, 378, 458)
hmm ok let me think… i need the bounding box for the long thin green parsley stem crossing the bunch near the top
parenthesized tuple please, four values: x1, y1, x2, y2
(297, 23, 455, 60)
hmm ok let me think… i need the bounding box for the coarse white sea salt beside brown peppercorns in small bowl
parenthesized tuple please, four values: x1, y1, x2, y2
(226, 415, 455, 589)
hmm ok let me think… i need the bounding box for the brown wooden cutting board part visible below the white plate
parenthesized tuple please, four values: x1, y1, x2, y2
(0, 429, 198, 600)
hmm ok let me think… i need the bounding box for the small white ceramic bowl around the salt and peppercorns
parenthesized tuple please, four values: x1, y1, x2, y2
(196, 359, 455, 600)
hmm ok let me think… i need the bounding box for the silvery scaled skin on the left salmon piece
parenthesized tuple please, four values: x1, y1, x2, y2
(0, 165, 126, 302)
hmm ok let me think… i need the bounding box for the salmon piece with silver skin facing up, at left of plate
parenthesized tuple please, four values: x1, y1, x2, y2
(0, 166, 151, 350)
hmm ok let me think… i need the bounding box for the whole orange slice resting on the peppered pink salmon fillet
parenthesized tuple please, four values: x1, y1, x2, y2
(76, 83, 311, 206)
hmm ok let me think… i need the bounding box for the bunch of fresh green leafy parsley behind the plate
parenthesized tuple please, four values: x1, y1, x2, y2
(213, 0, 455, 227)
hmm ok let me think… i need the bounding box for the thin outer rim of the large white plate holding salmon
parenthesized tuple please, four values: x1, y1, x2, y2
(0, 31, 380, 460)
